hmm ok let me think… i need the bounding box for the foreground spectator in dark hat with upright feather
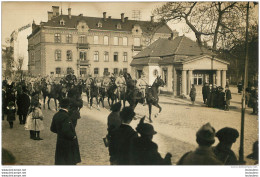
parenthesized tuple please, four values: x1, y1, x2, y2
(131, 117, 172, 165)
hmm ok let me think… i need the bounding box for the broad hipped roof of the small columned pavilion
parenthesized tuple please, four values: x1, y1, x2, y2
(134, 36, 213, 59)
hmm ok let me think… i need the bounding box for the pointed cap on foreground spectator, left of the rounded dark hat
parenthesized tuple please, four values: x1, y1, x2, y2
(196, 123, 215, 142)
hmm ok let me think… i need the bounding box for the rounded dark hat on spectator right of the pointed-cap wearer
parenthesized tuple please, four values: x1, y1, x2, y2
(216, 127, 239, 143)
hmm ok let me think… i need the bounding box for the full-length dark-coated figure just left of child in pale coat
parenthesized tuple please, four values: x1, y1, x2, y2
(16, 87, 30, 124)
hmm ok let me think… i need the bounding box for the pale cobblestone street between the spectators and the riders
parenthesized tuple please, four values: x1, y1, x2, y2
(2, 88, 258, 165)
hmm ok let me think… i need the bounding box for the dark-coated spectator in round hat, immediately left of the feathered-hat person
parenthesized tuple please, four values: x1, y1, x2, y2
(109, 107, 138, 165)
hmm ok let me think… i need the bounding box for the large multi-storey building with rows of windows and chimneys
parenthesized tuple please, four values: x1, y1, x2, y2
(28, 6, 175, 77)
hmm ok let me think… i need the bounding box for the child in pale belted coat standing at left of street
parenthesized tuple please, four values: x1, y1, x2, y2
(24, 101, 44, 140)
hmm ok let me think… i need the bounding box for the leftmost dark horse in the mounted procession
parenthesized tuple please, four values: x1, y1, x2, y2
(41, 80, 62, 111)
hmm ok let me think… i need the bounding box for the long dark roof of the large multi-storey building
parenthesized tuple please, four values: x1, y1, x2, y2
(43, 15, 172, 34)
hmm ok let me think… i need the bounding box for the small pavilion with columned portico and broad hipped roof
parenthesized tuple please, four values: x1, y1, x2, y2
(131, 36, 229, 96)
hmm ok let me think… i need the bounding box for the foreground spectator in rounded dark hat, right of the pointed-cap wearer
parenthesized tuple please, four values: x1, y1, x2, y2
(213, 127, 239, 165)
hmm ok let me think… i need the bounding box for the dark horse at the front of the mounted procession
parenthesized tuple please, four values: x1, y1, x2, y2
(126, 76, 165, 123)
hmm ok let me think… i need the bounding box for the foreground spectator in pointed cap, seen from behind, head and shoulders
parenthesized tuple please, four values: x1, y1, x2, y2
(177, 123, 223, 165)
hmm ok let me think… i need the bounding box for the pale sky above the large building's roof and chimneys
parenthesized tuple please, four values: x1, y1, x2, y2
(1, 2, 195, 44)
